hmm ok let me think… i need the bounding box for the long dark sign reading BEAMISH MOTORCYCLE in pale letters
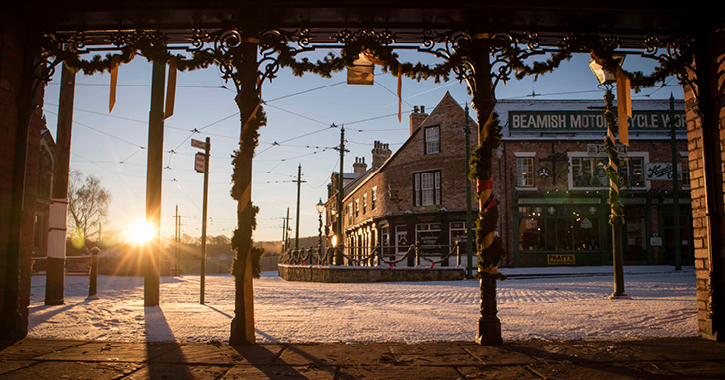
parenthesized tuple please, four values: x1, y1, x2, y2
(509, 111, 686, 132)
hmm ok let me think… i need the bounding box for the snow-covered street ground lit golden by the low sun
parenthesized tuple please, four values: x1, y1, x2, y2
(28, 266, 697, 343)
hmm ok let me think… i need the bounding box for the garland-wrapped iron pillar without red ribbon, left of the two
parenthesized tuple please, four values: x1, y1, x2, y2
(229, 38, 263, 345)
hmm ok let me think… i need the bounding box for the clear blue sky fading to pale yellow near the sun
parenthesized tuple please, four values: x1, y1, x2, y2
(44, 50, 683, 241)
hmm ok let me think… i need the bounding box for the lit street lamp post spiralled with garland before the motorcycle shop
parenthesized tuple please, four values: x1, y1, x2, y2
(589, 56, 629, 299)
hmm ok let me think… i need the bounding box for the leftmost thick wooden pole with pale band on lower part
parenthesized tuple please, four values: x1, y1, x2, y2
(45, 64, 75, 305)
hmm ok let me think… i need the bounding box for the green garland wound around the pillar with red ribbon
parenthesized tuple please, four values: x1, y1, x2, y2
(468, 112, 506, 280)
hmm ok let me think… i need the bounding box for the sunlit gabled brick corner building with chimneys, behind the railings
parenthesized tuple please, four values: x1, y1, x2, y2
(326, 93, 478, 266)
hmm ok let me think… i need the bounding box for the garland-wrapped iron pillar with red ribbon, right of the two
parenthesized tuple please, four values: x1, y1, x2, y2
(469, 34, 503, 345)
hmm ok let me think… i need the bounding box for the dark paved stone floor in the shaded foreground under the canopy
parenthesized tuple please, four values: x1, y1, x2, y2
(0, 338, 725, 380)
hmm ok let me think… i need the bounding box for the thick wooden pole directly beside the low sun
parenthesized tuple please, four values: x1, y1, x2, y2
(144, 61, 166, 306)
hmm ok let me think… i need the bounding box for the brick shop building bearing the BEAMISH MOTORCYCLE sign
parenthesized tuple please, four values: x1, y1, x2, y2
(493, 100, 693, 266)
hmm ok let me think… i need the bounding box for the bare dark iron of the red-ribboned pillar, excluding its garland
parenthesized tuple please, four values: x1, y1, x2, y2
(469, 34, 503, 346)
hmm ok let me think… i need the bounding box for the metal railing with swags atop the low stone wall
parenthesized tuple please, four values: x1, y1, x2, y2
(279, 242, 463, 268)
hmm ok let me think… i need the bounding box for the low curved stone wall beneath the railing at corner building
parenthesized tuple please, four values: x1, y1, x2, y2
(278, 264, 466, 282)
